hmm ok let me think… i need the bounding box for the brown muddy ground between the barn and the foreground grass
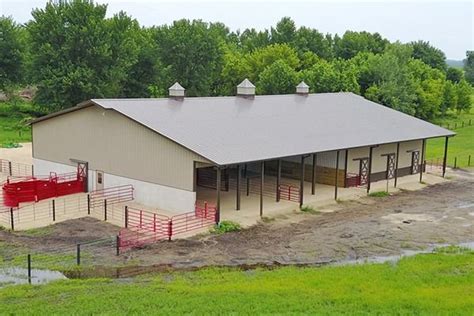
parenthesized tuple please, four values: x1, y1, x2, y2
(0, 171, 474, 268)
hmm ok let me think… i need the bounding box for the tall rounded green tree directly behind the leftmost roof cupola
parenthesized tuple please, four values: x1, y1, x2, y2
(155, 20, 223, 96)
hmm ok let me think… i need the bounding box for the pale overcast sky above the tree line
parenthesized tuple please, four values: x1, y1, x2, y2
(0, 0, 474, 60)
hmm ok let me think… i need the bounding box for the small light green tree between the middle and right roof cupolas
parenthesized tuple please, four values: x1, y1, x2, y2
(257, 60, 299, 94)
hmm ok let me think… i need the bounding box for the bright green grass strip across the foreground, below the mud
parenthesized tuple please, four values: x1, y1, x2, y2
(0, 248, 474, 315)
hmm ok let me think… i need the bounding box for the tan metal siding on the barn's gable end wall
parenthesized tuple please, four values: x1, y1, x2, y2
(33, 106, 209, 191)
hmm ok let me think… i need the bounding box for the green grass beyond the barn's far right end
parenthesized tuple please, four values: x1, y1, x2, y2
(426, 109, 474, 167)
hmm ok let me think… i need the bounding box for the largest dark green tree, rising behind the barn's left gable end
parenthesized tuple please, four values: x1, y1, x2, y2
(28, 0, 124, 110)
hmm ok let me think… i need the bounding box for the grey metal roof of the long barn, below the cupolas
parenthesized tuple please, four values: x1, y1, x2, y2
(33, 92, 455, 165)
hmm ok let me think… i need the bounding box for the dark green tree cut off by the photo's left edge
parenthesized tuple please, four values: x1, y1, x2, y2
(0, 16, 25, 95)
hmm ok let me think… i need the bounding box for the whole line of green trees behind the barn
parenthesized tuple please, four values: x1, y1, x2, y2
(0, 0, 474, 119)
